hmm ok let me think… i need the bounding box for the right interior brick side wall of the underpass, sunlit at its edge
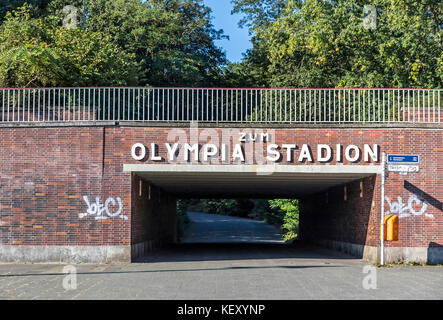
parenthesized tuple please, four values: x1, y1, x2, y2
(299, 176, 379, 258)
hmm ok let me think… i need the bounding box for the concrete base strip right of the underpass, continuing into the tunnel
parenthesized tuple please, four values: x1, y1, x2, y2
(316, 240, 443, 264)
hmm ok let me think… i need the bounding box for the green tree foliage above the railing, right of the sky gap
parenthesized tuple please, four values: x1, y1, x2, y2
(234, 0, 443, 88)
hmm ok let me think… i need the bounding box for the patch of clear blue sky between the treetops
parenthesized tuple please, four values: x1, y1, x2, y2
(203, 0, 252, 62)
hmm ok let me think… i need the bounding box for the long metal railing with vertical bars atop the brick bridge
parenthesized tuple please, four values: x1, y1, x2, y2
(0, 87, 443, 123)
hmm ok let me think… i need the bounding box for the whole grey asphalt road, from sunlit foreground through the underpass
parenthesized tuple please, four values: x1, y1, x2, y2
(0, 214, 443, 300)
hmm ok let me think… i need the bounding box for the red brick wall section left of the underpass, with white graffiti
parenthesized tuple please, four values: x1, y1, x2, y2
(0, 127, 131, 245)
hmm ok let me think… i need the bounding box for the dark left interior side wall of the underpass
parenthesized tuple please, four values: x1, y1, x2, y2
(131, 175, 177, 260)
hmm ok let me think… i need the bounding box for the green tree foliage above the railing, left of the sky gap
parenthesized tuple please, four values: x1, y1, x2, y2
(0, 0, 226, 87)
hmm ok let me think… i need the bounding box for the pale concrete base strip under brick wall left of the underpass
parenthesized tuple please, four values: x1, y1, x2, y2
(0, 245, 131, 264)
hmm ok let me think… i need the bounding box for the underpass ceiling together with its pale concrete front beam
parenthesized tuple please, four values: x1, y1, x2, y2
(126, 165, 379, 198)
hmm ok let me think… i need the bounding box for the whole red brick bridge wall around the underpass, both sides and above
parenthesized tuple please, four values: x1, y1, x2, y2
(0, 127, 443, 250)
